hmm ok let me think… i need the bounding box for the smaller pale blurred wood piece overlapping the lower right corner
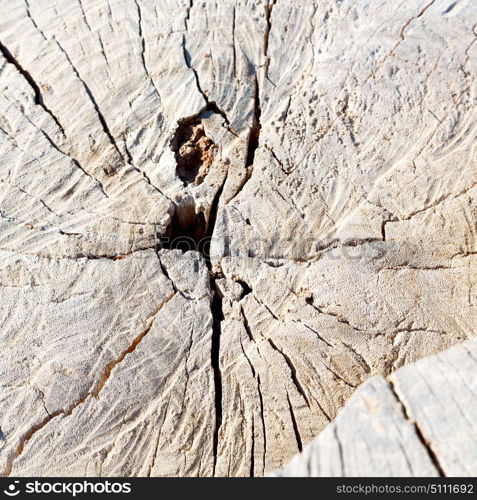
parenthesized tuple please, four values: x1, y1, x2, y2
(272, 339, 477, 477)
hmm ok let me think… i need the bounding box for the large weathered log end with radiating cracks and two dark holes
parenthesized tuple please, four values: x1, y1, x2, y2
(0, 0, 477, 476)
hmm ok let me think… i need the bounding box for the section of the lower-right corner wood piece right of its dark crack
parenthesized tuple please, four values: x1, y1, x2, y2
(391, 341, 477, 476)
